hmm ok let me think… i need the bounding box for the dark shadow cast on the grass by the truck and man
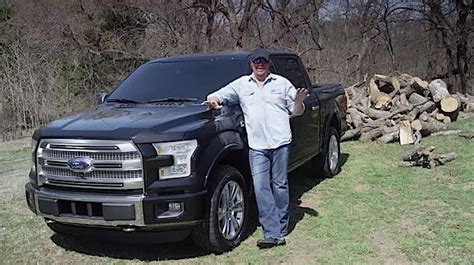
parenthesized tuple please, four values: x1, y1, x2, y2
(51, 154, 349, 261)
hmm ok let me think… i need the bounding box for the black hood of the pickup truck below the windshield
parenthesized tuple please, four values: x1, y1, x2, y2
(34, 104, 213, 142)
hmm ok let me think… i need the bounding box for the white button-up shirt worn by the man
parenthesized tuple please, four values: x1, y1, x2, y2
(208, 74, 296, 150)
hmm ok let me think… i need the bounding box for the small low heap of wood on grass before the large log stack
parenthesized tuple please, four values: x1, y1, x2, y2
(400, 146, 457, 168)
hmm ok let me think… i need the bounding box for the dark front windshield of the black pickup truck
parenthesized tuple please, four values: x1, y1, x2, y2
(107, 59, 250, 102)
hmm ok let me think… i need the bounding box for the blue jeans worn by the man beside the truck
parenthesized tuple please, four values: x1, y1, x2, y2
(249, 144, 290, 238)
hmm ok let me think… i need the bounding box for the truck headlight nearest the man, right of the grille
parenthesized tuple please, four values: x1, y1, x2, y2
(153, 140, 197, 179)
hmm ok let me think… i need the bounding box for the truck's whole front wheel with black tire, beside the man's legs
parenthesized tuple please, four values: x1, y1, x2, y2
(192, 166, 249, 253)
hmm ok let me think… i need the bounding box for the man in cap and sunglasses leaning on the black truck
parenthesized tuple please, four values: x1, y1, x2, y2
(207, 49, 307, 248)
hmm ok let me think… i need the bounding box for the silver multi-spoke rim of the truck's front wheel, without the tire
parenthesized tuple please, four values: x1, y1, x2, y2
(217, 180, 245, 240)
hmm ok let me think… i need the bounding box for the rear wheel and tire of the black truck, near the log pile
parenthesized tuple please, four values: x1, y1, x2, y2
(312, 127, 341, 178)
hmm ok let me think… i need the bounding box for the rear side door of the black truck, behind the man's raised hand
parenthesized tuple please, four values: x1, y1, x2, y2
(272, 55, 320, 168)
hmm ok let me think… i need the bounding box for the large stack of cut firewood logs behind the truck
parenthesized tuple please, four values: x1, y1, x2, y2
(341, 74, 474, 144)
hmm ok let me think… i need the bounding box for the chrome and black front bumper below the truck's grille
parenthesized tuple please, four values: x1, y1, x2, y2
(25, 183, 206, 231)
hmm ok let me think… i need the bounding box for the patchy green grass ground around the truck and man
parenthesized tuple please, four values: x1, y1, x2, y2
(0, 119, 474, 264)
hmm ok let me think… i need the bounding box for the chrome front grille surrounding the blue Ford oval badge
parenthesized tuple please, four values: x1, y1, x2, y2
(37, 139, 143, 190)
